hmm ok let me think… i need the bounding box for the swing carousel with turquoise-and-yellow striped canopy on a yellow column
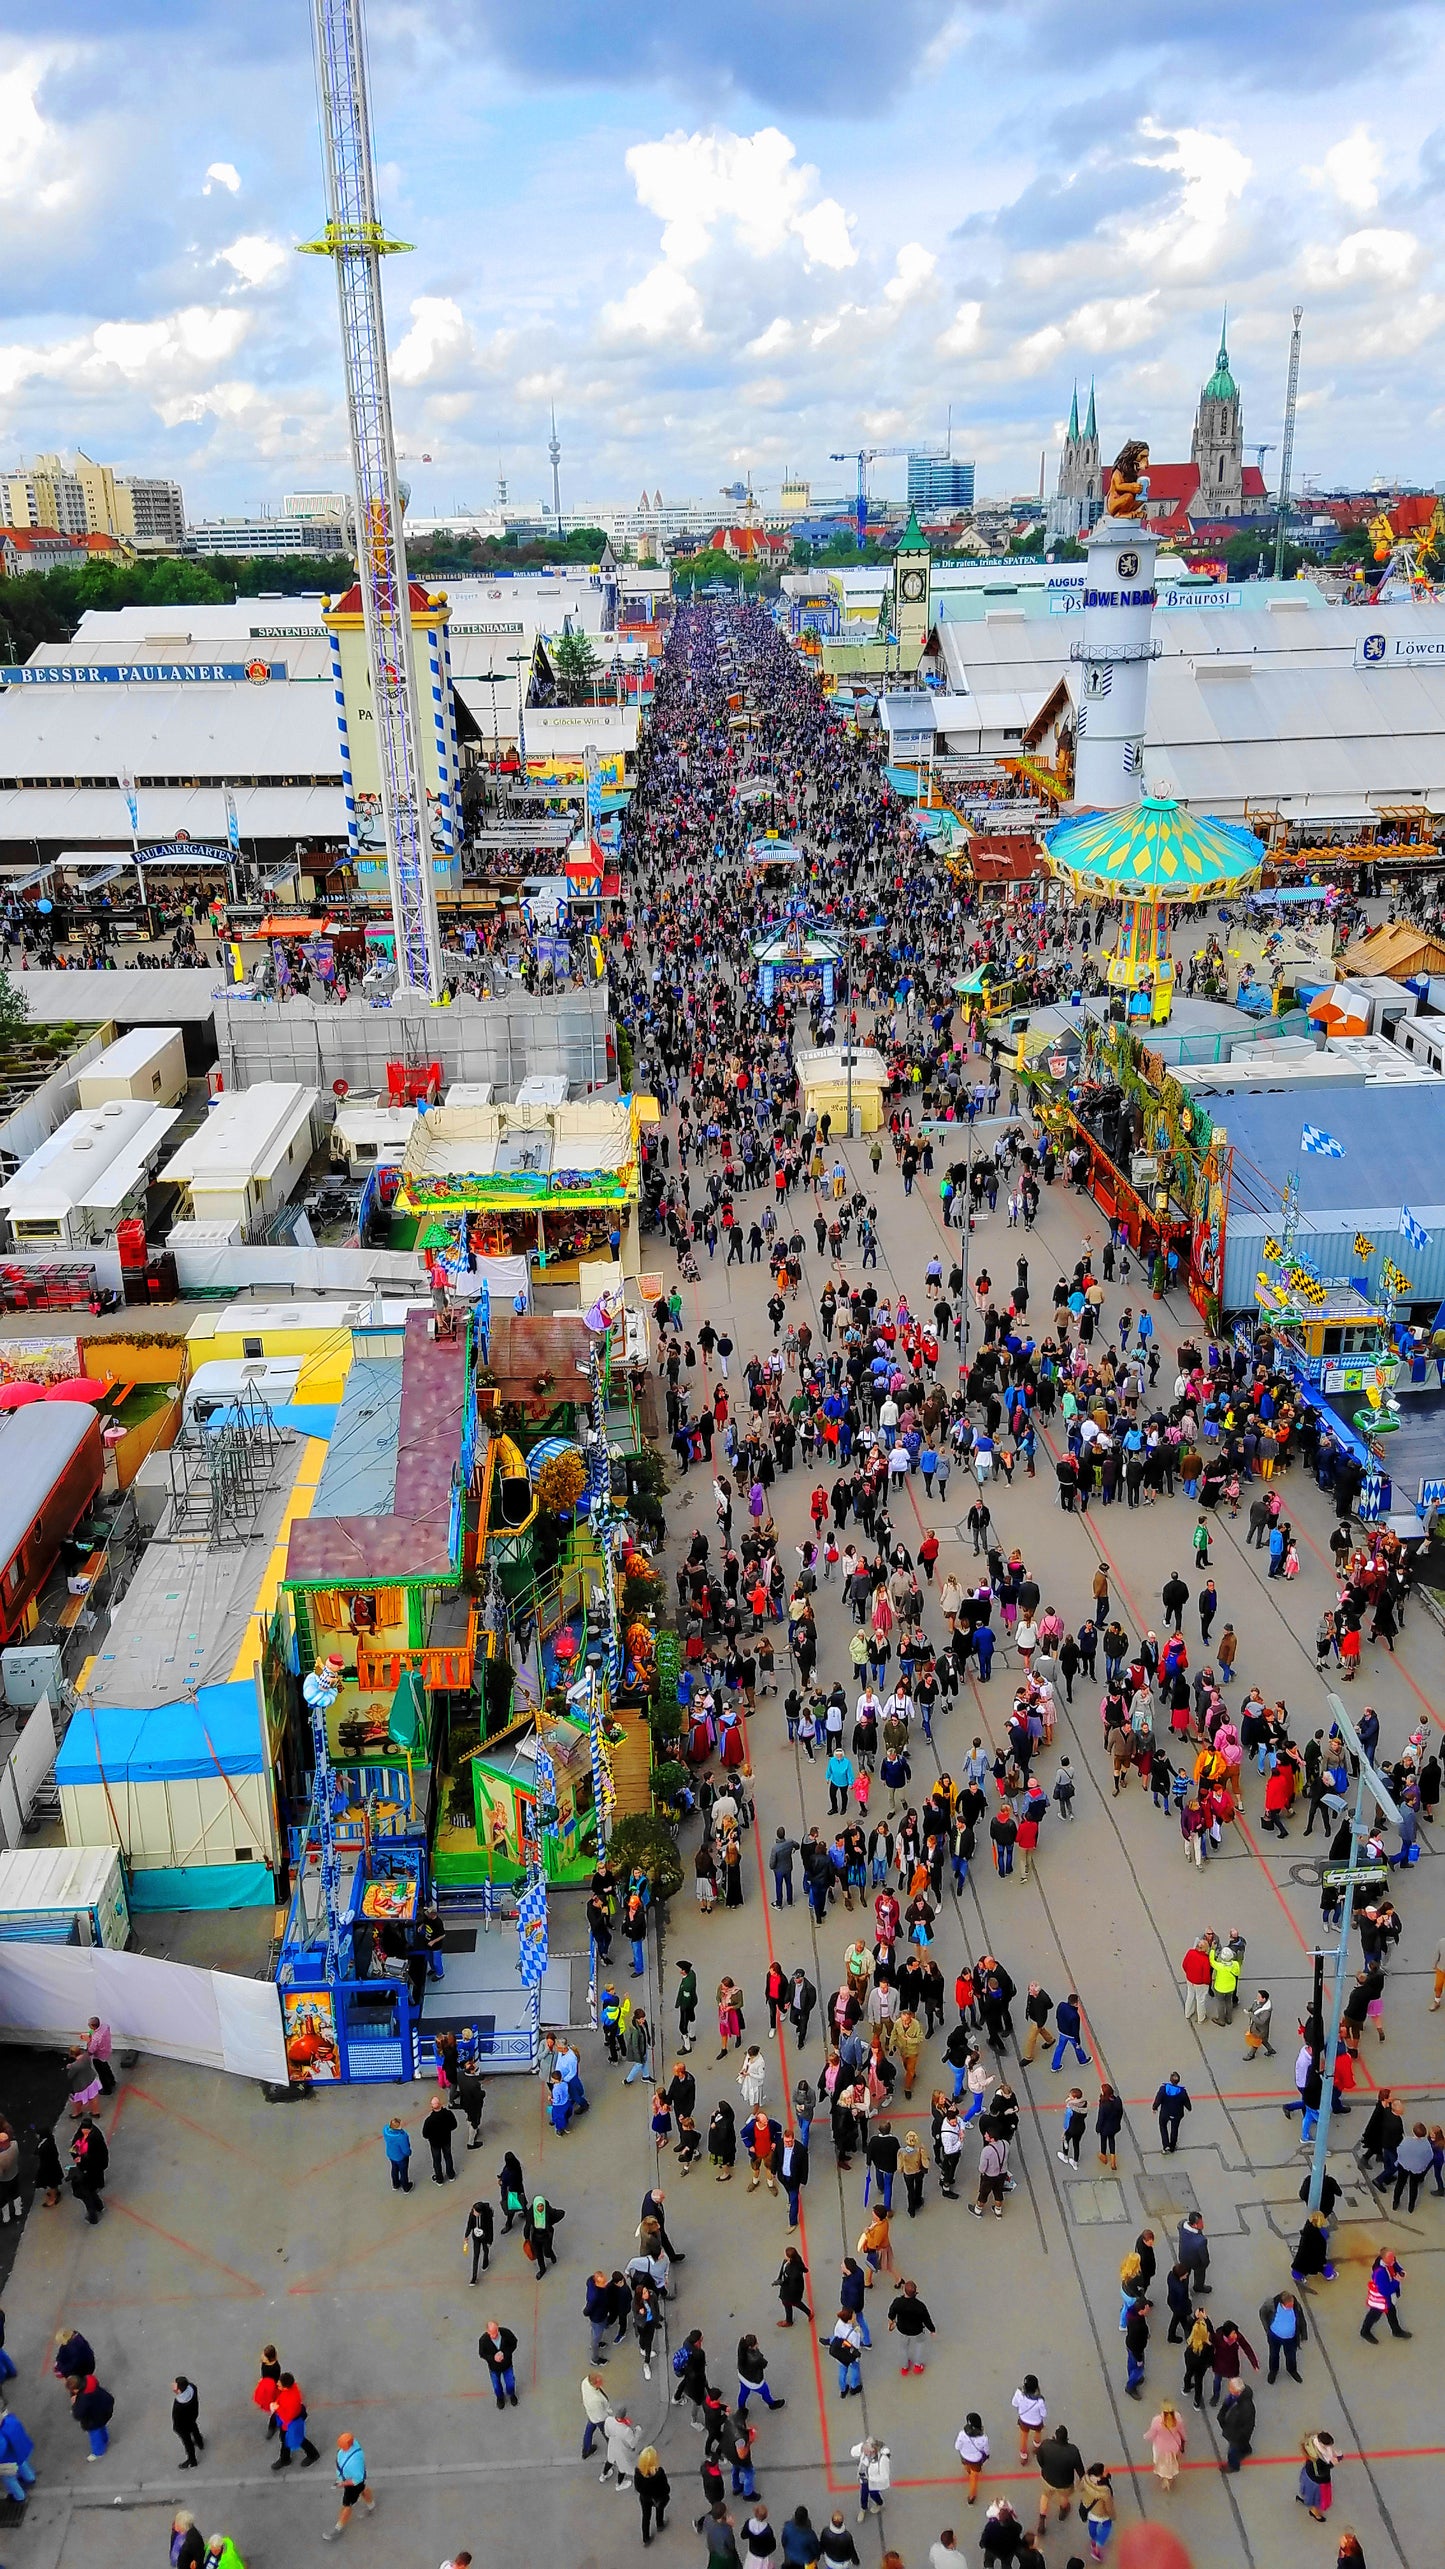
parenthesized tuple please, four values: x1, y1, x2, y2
(1044, 794, 1265, 1025)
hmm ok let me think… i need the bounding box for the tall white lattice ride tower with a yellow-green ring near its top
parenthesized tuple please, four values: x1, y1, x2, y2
(301, 0, 442, 999)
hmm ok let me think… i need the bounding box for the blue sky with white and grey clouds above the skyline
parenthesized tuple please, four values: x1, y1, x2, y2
(0, 0, 1445, 514)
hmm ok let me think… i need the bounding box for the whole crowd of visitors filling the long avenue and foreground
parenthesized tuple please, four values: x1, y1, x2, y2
(0, 599, 1419, 2569)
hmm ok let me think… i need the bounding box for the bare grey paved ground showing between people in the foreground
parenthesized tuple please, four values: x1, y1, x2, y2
(0, 1120, 1445, 2569)
